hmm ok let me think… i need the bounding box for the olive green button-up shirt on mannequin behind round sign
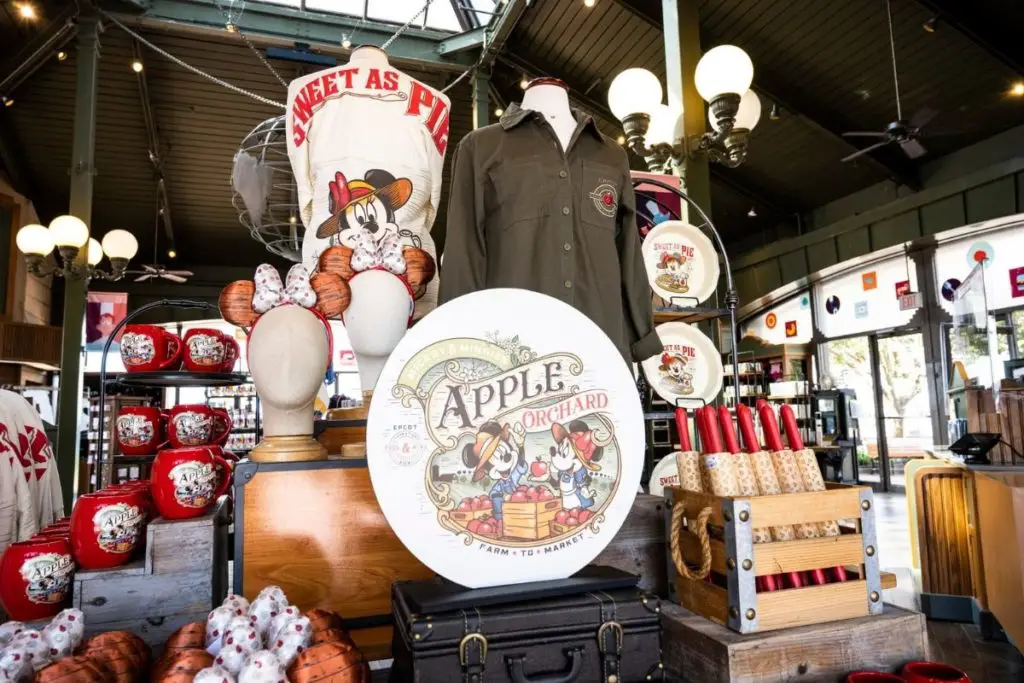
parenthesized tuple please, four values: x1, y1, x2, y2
(439, 104, 662, 361)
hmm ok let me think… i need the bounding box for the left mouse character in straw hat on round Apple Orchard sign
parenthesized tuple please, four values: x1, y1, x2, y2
(462, 422, 529, 523)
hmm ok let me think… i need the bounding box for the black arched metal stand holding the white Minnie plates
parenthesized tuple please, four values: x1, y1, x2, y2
(633, 177, 739, 482)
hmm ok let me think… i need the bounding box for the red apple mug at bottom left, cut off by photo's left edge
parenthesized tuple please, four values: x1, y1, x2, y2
(0, 537, 75, 622)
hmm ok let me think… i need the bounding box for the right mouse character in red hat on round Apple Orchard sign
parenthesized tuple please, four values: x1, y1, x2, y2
(549, 420, 604, 510)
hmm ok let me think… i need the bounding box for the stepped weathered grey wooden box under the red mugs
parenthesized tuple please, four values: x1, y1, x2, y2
(72, 498, 229, 649)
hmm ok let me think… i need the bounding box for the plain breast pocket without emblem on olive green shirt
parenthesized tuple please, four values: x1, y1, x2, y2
(487, 157, 551, 229)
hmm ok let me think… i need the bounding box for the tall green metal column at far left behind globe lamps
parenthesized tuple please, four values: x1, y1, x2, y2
(57, 11, 102, 512)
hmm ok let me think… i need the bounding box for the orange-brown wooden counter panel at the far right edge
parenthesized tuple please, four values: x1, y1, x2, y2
(975, 472, 1024, 644)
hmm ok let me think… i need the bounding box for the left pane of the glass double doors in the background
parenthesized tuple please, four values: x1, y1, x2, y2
(825, 335, 882, 489)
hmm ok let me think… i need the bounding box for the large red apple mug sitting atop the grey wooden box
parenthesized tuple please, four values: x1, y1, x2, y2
(150, 446, 231, 519)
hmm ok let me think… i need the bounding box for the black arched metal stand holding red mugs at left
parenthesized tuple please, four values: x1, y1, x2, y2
(90, 299, 249, 489)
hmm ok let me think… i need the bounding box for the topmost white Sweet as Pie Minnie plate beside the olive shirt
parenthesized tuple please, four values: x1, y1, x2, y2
(642, 220, 719, 307)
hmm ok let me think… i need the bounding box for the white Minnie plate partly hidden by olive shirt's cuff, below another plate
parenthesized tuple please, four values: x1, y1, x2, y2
(642, 323, 723, 405)
